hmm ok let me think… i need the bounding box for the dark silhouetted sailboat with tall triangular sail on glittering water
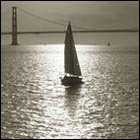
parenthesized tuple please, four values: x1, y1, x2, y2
(61, 22, 83, 85)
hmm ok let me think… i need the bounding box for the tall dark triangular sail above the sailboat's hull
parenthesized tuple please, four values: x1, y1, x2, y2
(64, 22, 82, 76)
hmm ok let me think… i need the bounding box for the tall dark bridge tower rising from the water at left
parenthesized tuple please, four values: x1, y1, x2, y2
(11, 7, 18, 45)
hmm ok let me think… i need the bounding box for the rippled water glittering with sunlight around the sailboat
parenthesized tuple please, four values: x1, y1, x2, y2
(1, 45, 139, 139)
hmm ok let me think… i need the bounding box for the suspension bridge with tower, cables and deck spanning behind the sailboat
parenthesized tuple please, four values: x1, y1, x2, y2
(1, 6, 139, 45)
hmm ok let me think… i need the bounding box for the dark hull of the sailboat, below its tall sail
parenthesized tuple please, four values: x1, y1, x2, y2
(61, 76, 83, 86)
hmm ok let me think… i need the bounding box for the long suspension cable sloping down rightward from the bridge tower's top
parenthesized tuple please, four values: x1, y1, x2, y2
(18, 7, 90, 30)
